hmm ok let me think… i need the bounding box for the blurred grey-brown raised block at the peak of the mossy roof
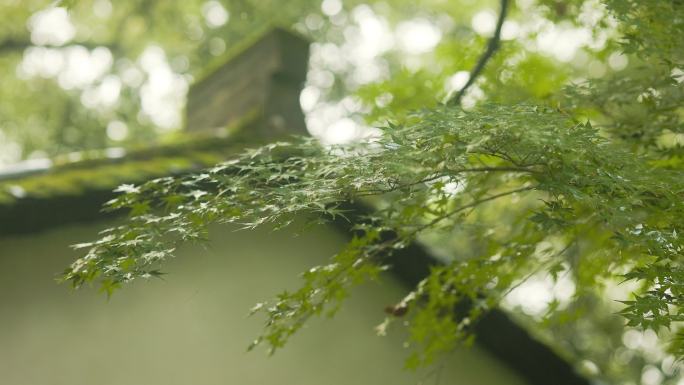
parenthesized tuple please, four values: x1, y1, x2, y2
(186, 29, 309, 137)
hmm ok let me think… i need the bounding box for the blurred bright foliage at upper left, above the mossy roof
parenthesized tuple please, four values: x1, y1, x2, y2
(0, 0, 317, 164)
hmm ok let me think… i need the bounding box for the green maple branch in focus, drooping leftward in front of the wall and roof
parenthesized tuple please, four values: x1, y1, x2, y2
(64, 104, 684, 362)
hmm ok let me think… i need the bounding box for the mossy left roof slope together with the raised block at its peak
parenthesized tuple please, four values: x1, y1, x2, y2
(0, 28, 308, 235)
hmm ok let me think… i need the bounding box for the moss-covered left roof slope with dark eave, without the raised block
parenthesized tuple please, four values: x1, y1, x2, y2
(0, 115, 272, 235)
